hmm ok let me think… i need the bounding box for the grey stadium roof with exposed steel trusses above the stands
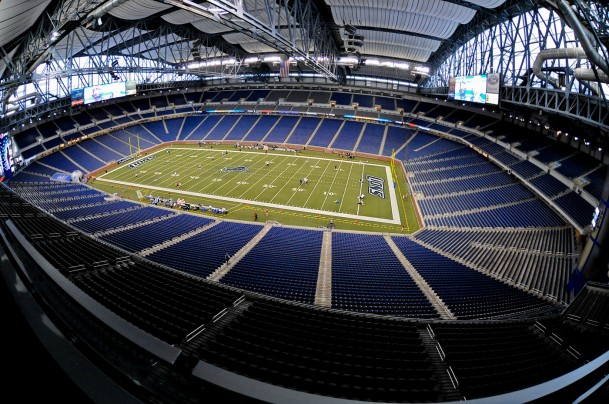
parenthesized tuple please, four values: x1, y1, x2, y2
(0, 0, 534, 81)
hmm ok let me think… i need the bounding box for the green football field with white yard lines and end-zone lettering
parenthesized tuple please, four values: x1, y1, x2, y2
(91, 145, 418, 233)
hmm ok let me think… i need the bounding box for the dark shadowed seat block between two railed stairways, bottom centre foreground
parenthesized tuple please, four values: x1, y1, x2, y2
(200, 301, 440, 402)
